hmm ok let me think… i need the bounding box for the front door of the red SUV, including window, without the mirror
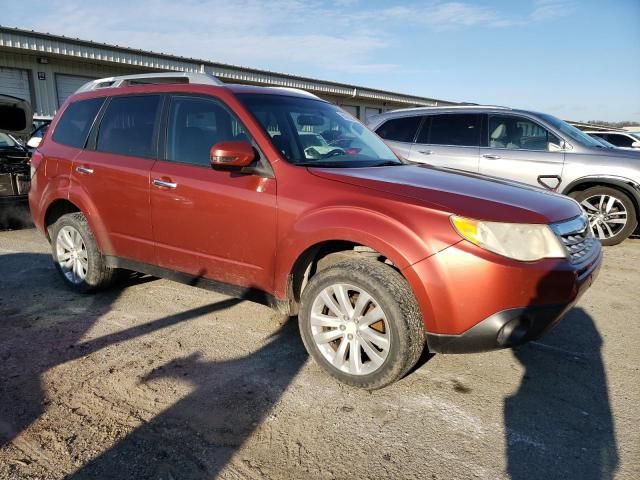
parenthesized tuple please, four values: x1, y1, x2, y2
(151, 95, 276, 291)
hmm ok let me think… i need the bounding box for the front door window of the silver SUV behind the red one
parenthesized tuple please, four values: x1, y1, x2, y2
(489, 115, 561, 152)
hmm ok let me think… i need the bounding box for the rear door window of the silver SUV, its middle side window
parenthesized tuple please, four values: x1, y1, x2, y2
(418, 113, 480, 147)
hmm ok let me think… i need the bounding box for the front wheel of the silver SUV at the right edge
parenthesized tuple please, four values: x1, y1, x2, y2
(570, 186, 638, 246)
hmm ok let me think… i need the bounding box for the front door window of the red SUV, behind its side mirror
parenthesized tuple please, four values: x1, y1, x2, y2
(166, 97, 251, 167)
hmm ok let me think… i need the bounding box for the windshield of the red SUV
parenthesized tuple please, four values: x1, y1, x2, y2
(238, 94, 402, 168)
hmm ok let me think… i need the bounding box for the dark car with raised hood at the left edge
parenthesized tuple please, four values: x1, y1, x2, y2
(0, 95, 31, 211)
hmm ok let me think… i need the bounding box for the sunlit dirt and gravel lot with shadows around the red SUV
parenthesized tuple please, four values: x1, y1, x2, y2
(0, 225, 640, 480)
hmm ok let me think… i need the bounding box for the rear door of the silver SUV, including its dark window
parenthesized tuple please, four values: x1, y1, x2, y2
(409, 113, 481, 172)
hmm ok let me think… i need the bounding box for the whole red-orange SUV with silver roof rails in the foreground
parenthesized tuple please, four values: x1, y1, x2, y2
(29, 74, 602, 389)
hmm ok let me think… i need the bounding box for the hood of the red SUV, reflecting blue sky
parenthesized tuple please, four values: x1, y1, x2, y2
(309, 165, 581, 223)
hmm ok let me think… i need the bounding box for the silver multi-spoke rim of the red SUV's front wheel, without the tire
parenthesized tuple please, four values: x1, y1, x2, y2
(310, 283, 391, 375)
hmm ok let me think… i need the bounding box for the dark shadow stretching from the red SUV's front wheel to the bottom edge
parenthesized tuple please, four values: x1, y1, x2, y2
(68, 319, 307, 480)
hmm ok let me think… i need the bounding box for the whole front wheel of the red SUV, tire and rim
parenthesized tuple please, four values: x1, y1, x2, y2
(298, 259, 425, 390)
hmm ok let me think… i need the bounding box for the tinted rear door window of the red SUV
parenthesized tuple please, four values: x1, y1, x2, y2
(96, 95, 160, 157)
